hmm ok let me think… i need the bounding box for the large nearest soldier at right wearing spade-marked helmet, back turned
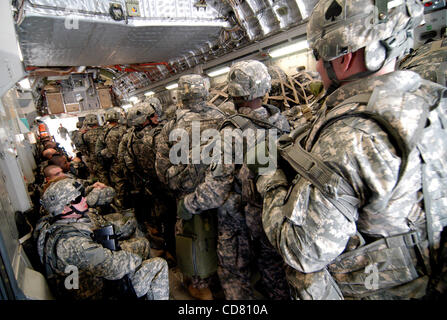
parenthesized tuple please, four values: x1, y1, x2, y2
(257, 0, 447, 299)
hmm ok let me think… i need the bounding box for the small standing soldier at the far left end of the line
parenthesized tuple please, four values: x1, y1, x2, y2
(82, 114, 110, 185)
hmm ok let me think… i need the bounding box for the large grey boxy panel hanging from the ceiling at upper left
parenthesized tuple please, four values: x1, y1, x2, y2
(17, 0, 230, 67)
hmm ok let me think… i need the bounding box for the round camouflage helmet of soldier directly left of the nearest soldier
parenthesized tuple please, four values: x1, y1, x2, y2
(228, 60, 271, 101)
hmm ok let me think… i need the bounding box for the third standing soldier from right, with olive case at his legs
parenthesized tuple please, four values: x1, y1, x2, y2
(156, 74, 225, 300)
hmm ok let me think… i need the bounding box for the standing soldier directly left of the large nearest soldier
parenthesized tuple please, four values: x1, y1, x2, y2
(179, 60, 290, 300)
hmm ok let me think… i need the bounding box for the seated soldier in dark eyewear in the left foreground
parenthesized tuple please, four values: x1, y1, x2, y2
(37, 179, 169, 300)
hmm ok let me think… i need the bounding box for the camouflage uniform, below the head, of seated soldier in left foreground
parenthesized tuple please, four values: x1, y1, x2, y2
(36, 212, 169, 299)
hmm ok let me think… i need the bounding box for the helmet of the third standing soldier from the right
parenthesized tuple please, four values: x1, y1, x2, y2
(178, 74, 210, 101)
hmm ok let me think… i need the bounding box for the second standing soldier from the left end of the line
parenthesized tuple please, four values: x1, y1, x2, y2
(95, 107, 127, 207)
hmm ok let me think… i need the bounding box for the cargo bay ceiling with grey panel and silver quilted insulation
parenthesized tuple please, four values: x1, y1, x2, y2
(13, 0, 317, 99)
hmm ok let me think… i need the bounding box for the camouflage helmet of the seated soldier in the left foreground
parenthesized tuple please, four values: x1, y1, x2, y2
(41, 178, 84, 216)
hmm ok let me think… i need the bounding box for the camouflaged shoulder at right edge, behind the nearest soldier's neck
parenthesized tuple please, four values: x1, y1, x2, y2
(399, 38, 447, 86)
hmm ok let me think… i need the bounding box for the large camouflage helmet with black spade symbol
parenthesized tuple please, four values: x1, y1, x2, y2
(307, 0, 424, 73)
